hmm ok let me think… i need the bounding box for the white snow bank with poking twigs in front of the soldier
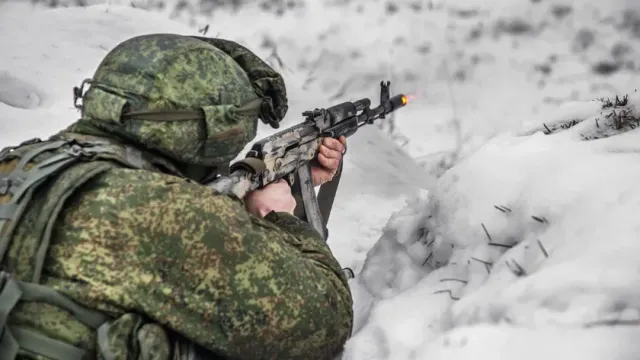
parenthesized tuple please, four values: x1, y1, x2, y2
(344, 93, 640, 360)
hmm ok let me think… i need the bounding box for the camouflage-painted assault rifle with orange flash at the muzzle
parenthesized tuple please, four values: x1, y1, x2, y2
(208, 81, 408, 241)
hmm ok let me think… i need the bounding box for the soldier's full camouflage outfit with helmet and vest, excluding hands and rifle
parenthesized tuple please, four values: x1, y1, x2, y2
(0, 34, 353, 360)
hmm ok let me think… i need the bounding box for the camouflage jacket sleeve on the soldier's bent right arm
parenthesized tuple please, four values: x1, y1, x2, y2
(47, 169, 353, 359)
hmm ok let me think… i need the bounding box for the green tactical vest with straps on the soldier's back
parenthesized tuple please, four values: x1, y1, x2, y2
(0, 134, 188, 360)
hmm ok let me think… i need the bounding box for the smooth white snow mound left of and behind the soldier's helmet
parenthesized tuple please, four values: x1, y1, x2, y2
(0, 2, 193, 146)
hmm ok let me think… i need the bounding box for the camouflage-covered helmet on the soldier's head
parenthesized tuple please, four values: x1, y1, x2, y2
(82, 34, 288, 166)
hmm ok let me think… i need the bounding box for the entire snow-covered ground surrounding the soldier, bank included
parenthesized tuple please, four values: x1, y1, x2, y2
(0, 0, 640, 360)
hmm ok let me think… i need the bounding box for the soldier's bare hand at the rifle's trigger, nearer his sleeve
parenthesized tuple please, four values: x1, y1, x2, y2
(244, 180, 296, 218)
